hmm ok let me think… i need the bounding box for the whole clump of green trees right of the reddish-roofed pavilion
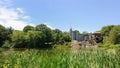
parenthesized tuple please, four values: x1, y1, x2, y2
(101, 25, 120, 44)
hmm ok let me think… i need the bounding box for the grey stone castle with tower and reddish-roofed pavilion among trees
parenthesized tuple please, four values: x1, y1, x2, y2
(70, 28, 102, 42)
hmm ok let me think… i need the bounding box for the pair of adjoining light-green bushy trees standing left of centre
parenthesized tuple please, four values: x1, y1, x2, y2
(12, 31, 45, 48)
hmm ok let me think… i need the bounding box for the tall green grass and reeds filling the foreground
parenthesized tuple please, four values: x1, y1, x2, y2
(0, 49, 120, 68)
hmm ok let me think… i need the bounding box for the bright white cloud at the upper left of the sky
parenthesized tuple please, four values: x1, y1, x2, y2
(0, 0, 34, 30)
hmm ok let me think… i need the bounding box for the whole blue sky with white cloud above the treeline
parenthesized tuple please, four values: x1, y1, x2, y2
(0, 0, 120, 32)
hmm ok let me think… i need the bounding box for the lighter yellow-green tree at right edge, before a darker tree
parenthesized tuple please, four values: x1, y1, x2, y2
(103, 25, 120, 44)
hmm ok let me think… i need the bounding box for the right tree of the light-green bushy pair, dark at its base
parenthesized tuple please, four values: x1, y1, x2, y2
(27, 31, 45, 48)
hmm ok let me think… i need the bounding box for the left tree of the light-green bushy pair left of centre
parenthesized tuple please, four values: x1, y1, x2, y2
(12, 31, 29, 48)
